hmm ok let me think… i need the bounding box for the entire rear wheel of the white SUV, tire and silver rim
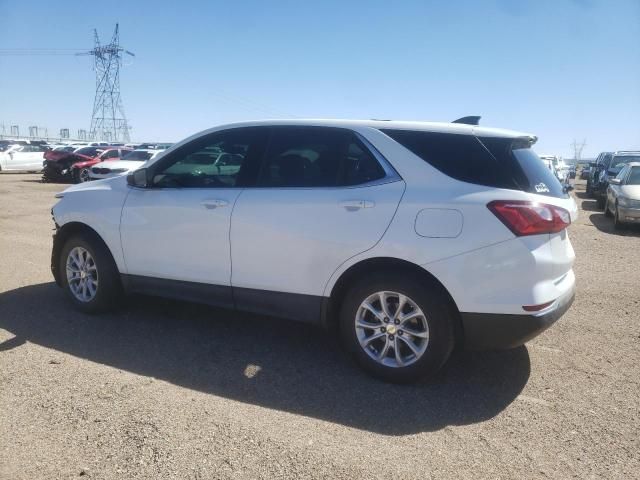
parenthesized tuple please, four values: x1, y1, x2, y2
(340, 275, 454, 383)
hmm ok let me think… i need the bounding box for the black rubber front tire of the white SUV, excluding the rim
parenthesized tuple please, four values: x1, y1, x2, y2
(58, 232, 122, 313)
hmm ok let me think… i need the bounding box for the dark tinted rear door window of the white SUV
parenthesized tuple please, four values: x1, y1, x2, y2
(258, 127, 385, 187)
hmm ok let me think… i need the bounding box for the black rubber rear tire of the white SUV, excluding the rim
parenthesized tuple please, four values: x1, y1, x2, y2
(340, 274, 455, 383)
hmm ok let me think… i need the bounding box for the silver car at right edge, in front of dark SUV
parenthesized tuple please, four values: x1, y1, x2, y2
(604, 161, 640, 229)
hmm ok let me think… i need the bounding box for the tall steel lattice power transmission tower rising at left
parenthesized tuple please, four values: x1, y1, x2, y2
(76, 23, 134, 143)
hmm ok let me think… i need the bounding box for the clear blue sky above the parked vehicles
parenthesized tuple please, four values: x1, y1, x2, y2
(0, 0, 640, 157)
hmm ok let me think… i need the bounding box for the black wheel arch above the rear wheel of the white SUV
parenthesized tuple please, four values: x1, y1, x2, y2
(322, 257, 464, 341)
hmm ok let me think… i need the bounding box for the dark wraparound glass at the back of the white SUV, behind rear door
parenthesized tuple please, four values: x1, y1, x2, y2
(382, 129, 567, 198)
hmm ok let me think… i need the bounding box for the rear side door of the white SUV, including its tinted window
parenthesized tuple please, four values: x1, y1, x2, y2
(231, 127, 404, 321)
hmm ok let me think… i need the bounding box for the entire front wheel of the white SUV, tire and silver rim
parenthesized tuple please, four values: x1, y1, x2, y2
(58, 233, 122, 313)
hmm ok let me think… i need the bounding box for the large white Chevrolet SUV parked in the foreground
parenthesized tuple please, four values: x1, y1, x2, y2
(51, 120, 577, 382)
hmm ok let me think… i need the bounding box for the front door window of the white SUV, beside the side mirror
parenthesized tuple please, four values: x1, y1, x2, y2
(152, 128, 267, 188)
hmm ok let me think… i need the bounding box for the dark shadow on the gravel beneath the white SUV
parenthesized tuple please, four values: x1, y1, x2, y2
(0, 283, 530, 435)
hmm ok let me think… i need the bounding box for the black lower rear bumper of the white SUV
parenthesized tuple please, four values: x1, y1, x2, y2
(460, 288, 575, 350)
